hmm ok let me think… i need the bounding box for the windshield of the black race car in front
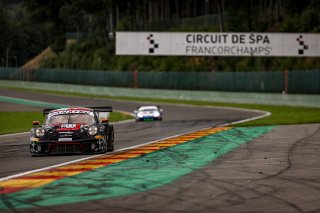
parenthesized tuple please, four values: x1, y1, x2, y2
(45, 114, 95, 126)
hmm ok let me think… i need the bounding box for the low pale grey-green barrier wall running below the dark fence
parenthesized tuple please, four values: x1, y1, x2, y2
(0, 80, 320, 108)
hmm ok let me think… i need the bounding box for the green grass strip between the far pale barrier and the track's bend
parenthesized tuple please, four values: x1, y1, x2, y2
(0, 88, 320, 131)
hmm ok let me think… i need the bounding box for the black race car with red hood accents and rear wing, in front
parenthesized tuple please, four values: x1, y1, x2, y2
(30, 107, 114, 156)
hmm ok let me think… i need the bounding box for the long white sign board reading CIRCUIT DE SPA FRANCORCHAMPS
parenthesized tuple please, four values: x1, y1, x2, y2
(116, 32, 320, 57)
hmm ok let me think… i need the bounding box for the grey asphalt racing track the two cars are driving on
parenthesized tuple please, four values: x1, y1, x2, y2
(0, 89, 261, 178)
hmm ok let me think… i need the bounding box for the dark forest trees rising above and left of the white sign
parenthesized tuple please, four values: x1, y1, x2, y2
(0, 0, 320, 69)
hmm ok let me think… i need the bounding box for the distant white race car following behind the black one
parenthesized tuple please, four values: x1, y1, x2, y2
(134, 106, 163, 121)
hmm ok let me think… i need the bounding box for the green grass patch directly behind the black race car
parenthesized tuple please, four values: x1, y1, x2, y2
(0, 112, 132, 135)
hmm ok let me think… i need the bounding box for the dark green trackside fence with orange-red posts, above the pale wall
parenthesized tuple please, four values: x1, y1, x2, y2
(0, 68, 320, 94)
